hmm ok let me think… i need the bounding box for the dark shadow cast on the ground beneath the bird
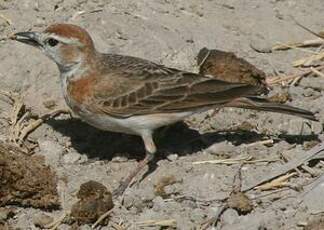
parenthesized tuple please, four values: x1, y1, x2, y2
(47, 118, 318, 160)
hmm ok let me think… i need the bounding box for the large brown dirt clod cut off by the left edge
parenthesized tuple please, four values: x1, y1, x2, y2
(0, 143, 60, 209)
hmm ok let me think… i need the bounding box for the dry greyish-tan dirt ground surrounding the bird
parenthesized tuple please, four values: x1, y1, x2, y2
(0, 0, 324, 230)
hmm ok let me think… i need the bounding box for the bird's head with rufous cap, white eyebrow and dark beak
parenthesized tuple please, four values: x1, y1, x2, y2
(11, 24, 96, 71)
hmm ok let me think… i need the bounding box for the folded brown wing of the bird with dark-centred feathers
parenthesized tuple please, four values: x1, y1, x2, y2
(88, 55, 256, 118)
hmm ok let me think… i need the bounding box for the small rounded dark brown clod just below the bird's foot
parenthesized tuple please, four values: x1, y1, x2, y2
(71, 181, 114, 225)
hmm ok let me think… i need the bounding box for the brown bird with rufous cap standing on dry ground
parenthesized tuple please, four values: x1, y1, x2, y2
(11, 23, 316, 195)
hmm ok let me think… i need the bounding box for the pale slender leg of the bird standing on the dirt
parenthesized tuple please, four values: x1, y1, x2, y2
(113, 132, 156, 196)
